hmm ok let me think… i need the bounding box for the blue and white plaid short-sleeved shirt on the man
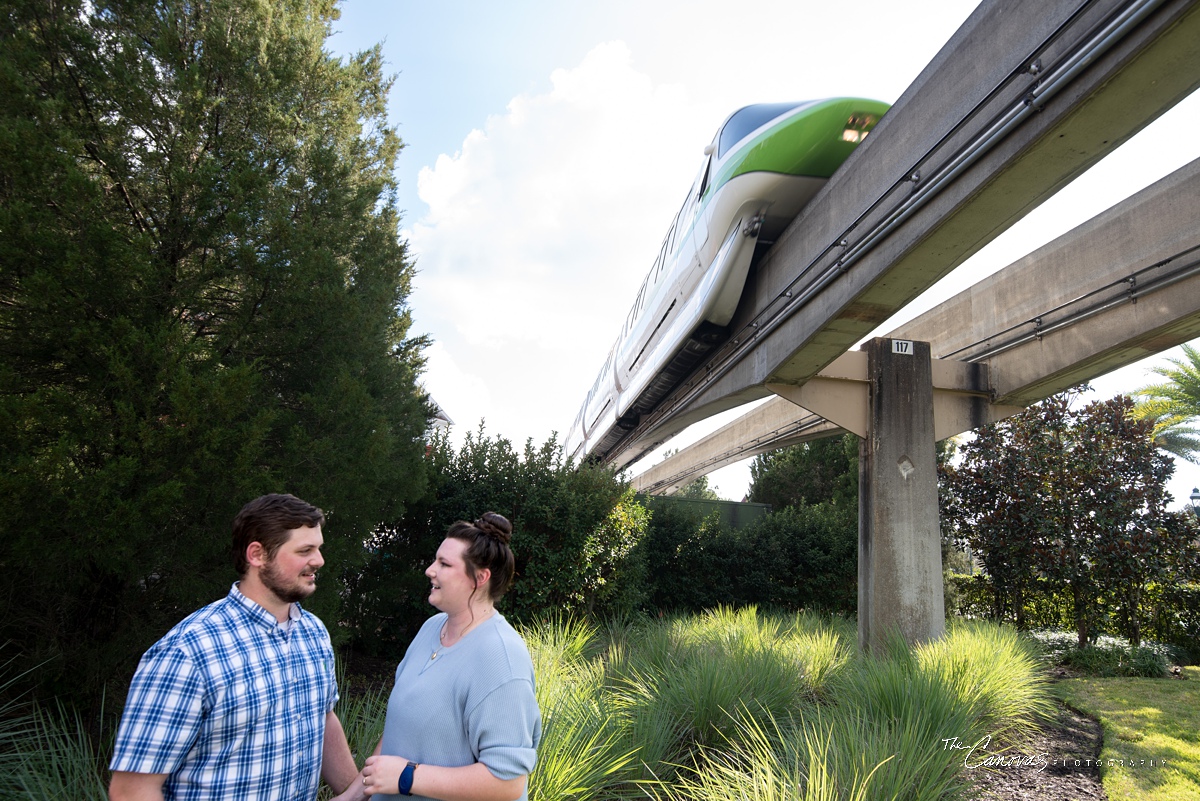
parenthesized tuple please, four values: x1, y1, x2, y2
(109, 584, 337, 801)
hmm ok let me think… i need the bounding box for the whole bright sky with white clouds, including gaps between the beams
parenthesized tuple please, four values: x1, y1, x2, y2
(328, 0, 1200, 507)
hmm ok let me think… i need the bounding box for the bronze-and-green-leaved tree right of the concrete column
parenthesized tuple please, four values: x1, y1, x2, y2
(942, 395, 1194, 646)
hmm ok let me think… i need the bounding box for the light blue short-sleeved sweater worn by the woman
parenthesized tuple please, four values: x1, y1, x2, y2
(376, 613, 541, 801)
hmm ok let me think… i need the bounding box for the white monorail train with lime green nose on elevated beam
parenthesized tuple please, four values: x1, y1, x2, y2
(564, 97, 888, 460)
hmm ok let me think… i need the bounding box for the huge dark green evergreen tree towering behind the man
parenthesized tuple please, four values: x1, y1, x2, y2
(0, 0, 427, 691)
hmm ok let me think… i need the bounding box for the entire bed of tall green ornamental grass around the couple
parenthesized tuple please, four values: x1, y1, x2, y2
(0, 609, 1048, 801)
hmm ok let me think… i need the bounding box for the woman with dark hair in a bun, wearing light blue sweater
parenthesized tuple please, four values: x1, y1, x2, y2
(338, 512, 541, 801)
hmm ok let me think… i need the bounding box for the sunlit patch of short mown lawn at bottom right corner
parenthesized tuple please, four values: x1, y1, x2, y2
(1054, 667, 1200, 801)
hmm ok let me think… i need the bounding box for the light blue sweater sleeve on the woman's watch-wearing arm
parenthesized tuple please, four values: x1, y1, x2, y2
(467, 679, 541, 779)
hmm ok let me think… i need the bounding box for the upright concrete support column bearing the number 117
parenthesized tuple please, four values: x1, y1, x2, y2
(858, 339, 946, 651)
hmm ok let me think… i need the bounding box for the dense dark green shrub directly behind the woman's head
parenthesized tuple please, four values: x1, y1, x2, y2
(348, 424, 648, 658)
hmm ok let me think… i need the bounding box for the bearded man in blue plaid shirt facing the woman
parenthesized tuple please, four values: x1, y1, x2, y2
(108, 495, 358, 801)
